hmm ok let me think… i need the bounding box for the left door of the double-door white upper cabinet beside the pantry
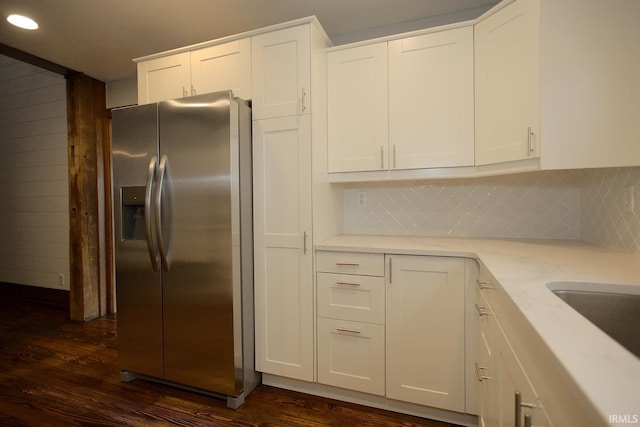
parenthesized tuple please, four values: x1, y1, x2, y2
(327, 43, 389, 172)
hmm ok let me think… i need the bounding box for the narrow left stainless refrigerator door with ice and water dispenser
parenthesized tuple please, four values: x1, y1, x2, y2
(113, 104, 163, 377)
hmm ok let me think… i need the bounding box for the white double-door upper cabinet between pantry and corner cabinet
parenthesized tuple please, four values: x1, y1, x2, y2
(327, 27, 474, 172)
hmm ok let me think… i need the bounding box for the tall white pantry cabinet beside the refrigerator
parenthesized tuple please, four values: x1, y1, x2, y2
(251, 20, 329, 381)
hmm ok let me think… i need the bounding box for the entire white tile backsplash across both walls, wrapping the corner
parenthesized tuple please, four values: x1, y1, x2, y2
(344, 167, 640, 251)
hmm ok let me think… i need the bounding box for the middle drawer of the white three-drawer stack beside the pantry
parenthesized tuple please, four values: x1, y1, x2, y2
(318, 273, 385, 325)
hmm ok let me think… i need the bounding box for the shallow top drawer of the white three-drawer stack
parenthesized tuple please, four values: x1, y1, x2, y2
(316, 251, 384, 277)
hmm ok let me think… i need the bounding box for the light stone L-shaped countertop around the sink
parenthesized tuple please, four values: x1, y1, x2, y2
(315, 235, 640, 425)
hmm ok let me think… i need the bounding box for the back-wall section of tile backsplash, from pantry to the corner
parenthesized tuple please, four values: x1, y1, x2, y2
(344, 171, 580, 239)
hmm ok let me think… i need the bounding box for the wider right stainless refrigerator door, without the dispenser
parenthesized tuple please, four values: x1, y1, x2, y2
(156, 92, 242, 395)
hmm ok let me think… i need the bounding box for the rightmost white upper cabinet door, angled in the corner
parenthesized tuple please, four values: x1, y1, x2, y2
(475, 0, 540, 165)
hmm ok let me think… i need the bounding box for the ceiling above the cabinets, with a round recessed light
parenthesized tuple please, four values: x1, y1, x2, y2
(0, 0, 497, 81)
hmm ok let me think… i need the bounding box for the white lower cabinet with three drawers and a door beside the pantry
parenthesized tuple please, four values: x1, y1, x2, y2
(316, 251, 466, 413)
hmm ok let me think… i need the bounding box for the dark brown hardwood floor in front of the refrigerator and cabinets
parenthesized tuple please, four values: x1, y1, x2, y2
(0, 299, 460, 427)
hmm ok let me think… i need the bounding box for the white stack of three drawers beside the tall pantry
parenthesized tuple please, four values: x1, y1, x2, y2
(316, 252, 385, 396)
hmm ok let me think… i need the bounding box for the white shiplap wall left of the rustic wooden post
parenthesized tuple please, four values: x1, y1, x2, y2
(0, 55, 69, 290)
